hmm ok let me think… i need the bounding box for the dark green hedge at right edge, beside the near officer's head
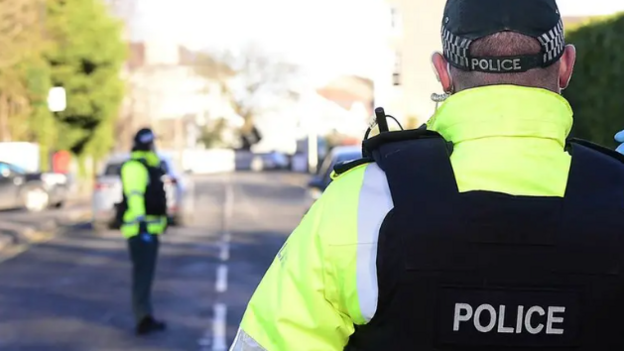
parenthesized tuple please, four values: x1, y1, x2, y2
(563, 13, 624, 147)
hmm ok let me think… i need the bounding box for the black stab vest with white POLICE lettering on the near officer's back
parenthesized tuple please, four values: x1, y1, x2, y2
(345, 130, 624, 351)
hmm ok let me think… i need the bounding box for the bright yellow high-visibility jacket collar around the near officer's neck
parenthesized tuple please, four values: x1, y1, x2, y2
(427, 85, 573, 146)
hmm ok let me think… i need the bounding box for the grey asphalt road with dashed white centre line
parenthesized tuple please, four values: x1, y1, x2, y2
(0, 173, 307, 351)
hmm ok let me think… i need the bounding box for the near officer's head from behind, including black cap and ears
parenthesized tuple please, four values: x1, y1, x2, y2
(434, 0, 573, 92)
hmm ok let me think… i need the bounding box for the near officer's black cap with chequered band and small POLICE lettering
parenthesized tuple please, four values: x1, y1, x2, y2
(442, 0, 565, 73)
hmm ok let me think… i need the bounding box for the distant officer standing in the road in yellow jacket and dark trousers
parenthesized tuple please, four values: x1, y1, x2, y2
(119, 128, 167, 335)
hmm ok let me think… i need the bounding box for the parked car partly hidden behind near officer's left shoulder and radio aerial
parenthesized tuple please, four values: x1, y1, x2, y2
(308, 145, 362, 200)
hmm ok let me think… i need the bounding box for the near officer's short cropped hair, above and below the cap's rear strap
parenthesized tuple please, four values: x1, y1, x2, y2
(451, 32, 559, 92)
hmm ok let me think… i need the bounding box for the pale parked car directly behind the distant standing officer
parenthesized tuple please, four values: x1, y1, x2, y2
(92, 154, 193, 229)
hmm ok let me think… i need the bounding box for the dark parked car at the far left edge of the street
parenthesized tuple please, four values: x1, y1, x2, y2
(0, 162, 69, 212)
